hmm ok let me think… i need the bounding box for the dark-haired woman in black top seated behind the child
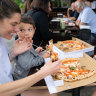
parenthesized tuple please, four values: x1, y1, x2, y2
(26, 0, 52, 46)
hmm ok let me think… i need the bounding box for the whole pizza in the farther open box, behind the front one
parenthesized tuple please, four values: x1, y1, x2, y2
(56, 40, 85, 52)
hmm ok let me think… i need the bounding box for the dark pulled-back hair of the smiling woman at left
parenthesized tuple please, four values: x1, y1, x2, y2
(0, 0, 21, 20)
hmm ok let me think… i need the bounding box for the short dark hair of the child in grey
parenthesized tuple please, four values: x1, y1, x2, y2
(20, 14, 35, 28)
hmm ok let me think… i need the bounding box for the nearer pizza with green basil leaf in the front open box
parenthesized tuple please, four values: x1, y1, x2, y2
(53, 58, 95, 82)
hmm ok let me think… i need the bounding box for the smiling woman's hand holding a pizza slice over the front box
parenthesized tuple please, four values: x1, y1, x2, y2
(41, 60, 61, 76)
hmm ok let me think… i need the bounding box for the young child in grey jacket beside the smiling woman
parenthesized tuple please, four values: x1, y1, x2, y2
(13, 15, 50, 80)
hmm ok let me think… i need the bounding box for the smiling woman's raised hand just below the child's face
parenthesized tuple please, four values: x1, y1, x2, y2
(11, 38, 33, 57)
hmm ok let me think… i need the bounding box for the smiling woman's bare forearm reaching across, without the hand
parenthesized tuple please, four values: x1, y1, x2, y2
(0, 71, 43, 96)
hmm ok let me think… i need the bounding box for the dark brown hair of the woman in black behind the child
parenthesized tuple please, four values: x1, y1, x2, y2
(31, 0, 51, 13)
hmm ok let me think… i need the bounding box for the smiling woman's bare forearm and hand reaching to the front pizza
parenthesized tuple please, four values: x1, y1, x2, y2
(0, 60, 61, 96)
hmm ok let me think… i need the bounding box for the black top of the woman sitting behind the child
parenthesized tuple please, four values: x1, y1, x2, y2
(26, 10, 52, 46)
